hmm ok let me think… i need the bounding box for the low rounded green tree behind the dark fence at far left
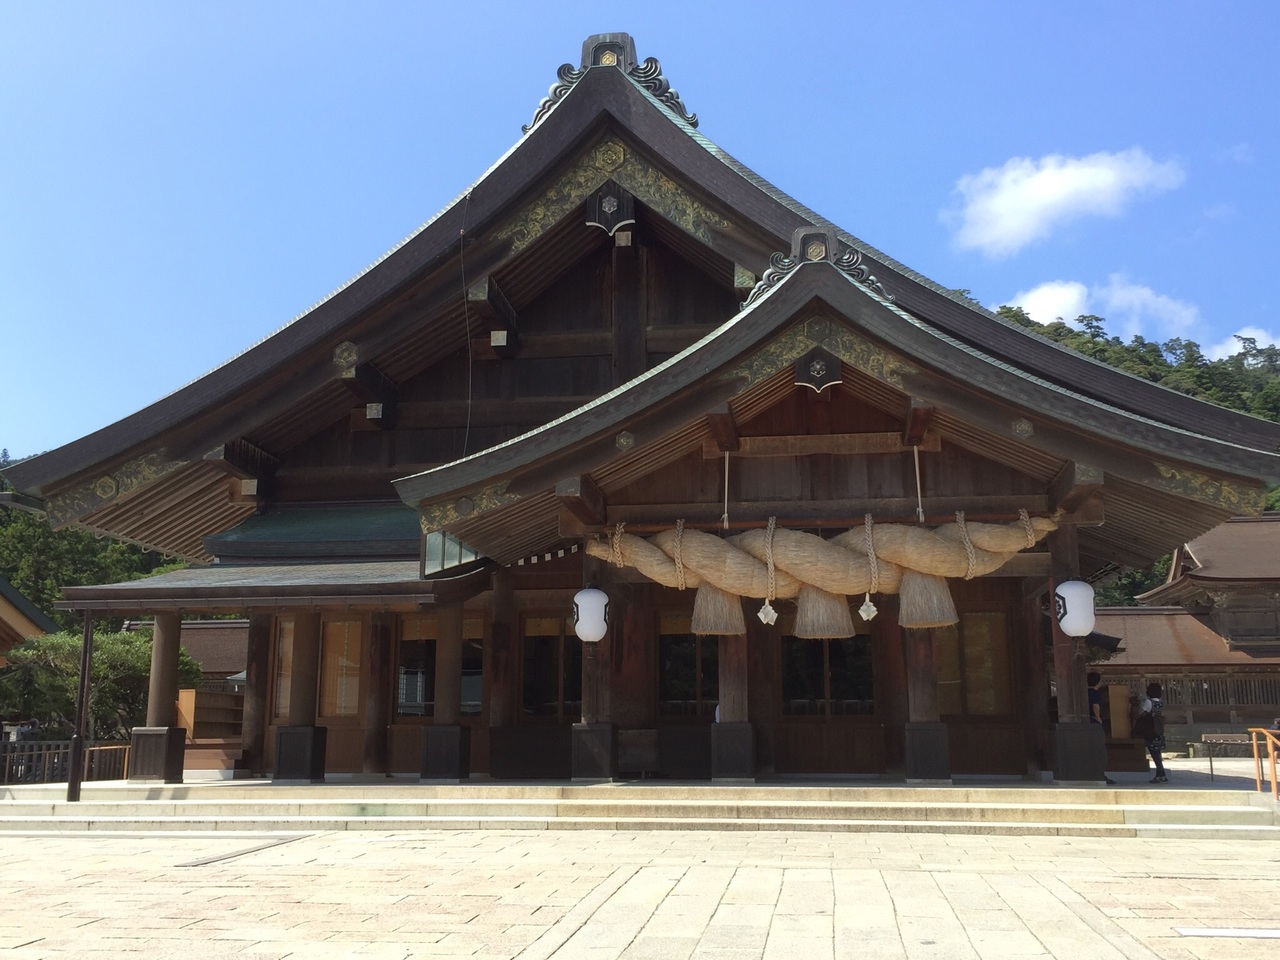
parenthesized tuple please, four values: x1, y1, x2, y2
(0, 630, 202, 740)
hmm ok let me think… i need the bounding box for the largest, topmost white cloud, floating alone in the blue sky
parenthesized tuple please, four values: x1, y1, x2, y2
(943, 147, 1185, 257)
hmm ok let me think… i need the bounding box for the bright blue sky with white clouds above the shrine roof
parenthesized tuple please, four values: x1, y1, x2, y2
(0, 0, 1280, 457)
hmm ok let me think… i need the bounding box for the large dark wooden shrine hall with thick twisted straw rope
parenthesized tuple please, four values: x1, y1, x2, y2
(5, 33, 1280, 781)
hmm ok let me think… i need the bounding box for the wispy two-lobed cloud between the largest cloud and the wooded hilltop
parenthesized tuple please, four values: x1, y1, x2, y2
(1009, 274, 1198, 343)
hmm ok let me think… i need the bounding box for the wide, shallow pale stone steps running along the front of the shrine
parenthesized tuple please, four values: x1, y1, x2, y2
(0, 778, 1280, 840)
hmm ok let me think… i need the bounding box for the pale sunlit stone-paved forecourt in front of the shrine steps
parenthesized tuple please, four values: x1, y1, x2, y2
(0, 757, 1280, 960)
